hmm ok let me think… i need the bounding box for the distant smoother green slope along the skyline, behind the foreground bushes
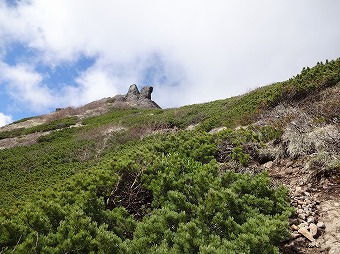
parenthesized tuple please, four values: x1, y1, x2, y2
(0, 59, 340, 207)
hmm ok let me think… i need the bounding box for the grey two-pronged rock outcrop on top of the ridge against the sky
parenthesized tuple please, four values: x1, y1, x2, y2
(113, 84, 160, 108)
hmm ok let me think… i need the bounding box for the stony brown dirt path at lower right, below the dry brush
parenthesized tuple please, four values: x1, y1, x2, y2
(263, 156, 340, 254)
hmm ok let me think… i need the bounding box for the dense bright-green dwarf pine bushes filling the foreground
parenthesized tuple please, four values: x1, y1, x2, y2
(0, 130, 291, 253)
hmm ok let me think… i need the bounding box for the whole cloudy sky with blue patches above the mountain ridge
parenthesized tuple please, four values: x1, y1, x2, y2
(0, 0, 340, 126)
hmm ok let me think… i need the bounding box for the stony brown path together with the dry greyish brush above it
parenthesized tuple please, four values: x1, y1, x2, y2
(256, 83, 340, 254)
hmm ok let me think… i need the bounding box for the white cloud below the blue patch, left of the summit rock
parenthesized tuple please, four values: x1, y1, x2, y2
(0, 62, 123, 113)
